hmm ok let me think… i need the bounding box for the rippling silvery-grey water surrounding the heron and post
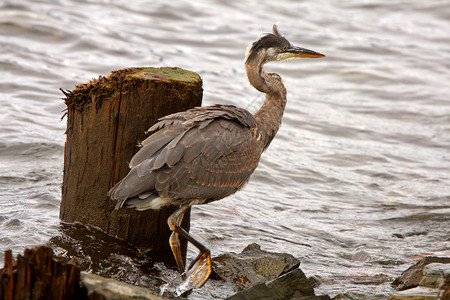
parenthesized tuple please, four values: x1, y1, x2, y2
(0, 0, 450, 299)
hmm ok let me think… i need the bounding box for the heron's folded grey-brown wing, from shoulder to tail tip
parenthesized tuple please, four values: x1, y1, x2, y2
(108, 105, 262, 206)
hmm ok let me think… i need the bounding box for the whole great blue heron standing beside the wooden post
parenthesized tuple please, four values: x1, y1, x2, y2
(108, 25, 324, 287)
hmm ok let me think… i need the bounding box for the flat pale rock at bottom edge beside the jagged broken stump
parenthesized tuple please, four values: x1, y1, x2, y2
(81, 272, 166, 300)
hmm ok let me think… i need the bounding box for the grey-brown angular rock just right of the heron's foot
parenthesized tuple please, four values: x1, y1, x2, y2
(213, 244, 300, 288)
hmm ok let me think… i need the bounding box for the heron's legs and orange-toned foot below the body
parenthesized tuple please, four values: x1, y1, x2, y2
(167, 204, 212, 287)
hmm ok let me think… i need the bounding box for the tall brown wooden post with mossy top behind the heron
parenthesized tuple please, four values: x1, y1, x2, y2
(60, 68, 203, 266)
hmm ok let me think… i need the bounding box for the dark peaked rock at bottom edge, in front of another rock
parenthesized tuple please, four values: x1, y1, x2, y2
(227, 269, 330, 300)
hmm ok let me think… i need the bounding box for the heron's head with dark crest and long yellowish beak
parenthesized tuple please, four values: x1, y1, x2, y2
(245, 25, 325, 64)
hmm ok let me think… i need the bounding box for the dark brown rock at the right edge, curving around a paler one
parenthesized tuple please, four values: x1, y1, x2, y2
(392, 256, 450, 291)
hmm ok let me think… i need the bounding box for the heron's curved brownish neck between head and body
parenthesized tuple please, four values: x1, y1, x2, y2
(245, 58, 287, 150)
